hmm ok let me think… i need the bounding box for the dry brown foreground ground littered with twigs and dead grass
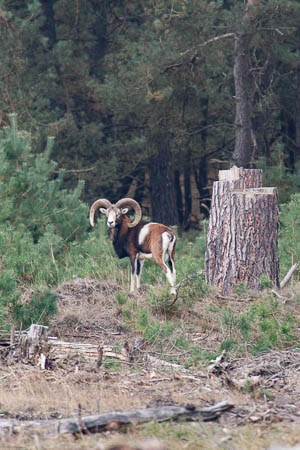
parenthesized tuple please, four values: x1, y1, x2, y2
(0, 279, 300, 450)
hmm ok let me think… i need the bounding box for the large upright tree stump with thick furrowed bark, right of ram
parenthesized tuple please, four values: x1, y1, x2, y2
(205, 166, 279, 294)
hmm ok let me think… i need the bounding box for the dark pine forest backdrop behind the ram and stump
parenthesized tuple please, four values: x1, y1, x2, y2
(0, 0, 300, 229)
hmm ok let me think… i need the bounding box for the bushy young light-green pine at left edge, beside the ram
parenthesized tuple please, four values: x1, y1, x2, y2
(0, 114, 88, 328)
